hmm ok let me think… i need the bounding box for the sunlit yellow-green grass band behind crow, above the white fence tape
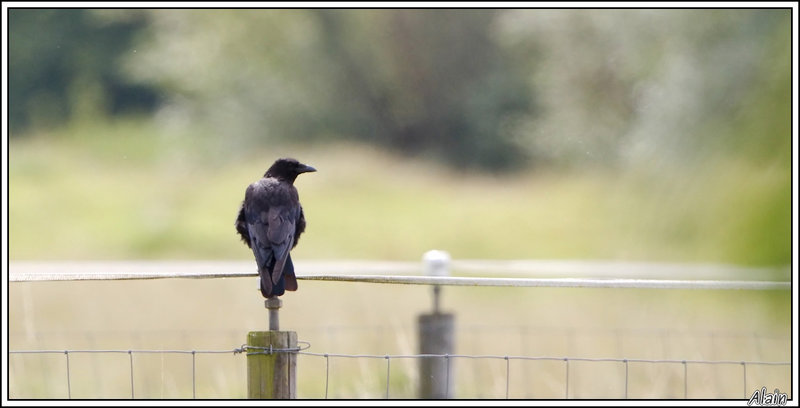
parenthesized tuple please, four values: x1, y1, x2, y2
(10, 121, 791, 265)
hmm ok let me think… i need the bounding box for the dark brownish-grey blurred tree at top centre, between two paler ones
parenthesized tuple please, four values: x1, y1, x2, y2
(315, 10, 531, 169)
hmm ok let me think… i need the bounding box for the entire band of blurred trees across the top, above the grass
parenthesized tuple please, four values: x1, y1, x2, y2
(9, 9, 790, 168)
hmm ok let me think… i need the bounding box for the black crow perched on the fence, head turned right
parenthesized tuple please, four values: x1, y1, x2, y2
(236, 159, 317, 298)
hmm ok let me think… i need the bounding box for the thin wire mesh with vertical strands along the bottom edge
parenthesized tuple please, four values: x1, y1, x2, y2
(9, 341, 791, 399)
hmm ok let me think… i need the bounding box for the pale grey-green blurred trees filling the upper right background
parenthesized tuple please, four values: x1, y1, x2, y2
(499, 9, 791, 167)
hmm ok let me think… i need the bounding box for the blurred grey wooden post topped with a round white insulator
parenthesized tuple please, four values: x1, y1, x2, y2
(417, 250, 455, 399)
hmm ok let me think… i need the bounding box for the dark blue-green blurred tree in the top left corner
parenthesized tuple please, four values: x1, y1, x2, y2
(8, 8, 158, 135)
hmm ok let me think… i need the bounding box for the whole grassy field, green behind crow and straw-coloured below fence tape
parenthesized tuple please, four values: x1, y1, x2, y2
(9, 118, 791, 398)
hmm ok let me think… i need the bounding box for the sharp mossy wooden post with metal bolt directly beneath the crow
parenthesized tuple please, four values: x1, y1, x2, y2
(247, 298, 297, 399)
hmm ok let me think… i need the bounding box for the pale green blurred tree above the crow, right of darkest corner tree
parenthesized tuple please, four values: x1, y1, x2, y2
(124, 10, 335, 152)
